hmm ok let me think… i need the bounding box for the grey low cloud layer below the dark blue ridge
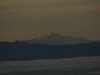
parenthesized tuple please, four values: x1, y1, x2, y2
(0, 56, 100, 75)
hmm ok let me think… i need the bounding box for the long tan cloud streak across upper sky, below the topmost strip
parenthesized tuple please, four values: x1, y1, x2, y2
(0, 4, 100, 16)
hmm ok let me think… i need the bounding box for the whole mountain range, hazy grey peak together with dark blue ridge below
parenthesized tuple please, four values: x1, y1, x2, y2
(0, 32, 100, 61)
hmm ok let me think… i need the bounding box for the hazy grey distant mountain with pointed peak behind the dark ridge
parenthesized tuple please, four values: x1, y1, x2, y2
(22, 32, 94, 45)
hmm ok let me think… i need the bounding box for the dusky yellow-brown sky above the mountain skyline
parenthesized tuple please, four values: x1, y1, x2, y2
(0, 0, 100, 41)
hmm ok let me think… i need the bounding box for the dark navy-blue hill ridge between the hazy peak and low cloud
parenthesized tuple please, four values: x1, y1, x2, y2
(0, 42, 100, 61)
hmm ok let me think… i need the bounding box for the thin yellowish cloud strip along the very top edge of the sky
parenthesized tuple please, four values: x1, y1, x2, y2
(0, 0, 100, 5)
